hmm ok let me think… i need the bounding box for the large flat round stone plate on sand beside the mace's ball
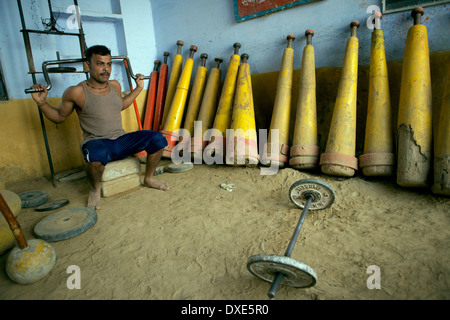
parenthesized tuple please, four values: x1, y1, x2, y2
(34, 208, 97, 242)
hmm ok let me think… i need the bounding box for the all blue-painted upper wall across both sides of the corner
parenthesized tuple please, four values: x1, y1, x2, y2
(0, 0, 450, 99)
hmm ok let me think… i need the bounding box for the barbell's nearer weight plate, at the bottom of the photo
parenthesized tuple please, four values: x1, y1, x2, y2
(247, 254, 317, 288)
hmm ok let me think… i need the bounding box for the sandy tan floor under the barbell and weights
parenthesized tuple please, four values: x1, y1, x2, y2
(0, 162, 450, 300)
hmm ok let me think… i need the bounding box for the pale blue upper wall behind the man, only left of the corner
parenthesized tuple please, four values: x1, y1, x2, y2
(0, 0, 156, 99)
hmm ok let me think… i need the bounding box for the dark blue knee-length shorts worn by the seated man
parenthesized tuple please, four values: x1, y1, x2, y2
(81, 130, 167, 165)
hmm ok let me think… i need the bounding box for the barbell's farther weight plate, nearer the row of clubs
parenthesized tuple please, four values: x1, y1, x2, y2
(289, 179, 335, 210)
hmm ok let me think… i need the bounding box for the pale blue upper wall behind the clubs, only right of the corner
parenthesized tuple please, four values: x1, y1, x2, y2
(152, 0, 450, 74)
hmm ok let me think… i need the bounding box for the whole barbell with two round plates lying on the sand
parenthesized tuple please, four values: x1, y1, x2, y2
(247, 179, 335, 298)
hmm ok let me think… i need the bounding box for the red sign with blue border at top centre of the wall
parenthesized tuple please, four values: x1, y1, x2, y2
(233, 0, 315, 22)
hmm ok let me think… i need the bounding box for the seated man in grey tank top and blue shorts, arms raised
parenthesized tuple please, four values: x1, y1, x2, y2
(31, 45, 169, 209)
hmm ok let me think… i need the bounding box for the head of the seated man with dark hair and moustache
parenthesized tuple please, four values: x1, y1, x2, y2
(86, 45, 112, 83)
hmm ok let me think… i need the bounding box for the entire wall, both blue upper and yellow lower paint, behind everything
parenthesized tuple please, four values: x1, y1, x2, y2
(0, 0, 450, 183)
